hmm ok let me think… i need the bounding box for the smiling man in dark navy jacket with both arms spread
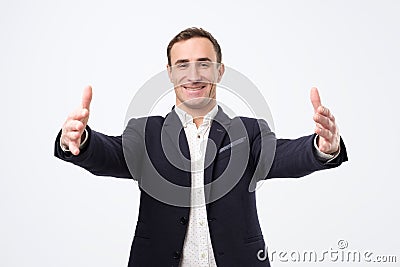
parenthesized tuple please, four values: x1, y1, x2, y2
(55, 28, 347, 267)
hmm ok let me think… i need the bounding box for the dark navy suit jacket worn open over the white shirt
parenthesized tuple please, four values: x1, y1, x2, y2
(55, 107, 347, 267)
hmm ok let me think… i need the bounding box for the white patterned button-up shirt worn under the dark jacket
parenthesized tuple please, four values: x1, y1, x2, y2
(175, 105, 218, 267)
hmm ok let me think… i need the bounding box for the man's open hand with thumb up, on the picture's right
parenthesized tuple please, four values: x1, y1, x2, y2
(310, 87, 340, 154)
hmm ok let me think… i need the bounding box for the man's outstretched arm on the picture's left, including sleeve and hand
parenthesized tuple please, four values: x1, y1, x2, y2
(54, 86, 136, 178)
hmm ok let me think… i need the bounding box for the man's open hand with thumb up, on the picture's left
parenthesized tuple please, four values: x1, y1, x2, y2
(60, 85, 92, 156)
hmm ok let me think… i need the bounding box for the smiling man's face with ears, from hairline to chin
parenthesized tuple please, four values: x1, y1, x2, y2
(167, 37, 224, 109)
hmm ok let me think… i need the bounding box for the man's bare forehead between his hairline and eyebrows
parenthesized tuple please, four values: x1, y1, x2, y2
(171, 37, 217, 63)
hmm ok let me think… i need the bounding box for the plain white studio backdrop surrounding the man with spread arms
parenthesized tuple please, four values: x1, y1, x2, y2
(0, 0, 400, 267)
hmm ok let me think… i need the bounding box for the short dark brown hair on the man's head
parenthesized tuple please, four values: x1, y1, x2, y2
(167, 27, 222, 66)
